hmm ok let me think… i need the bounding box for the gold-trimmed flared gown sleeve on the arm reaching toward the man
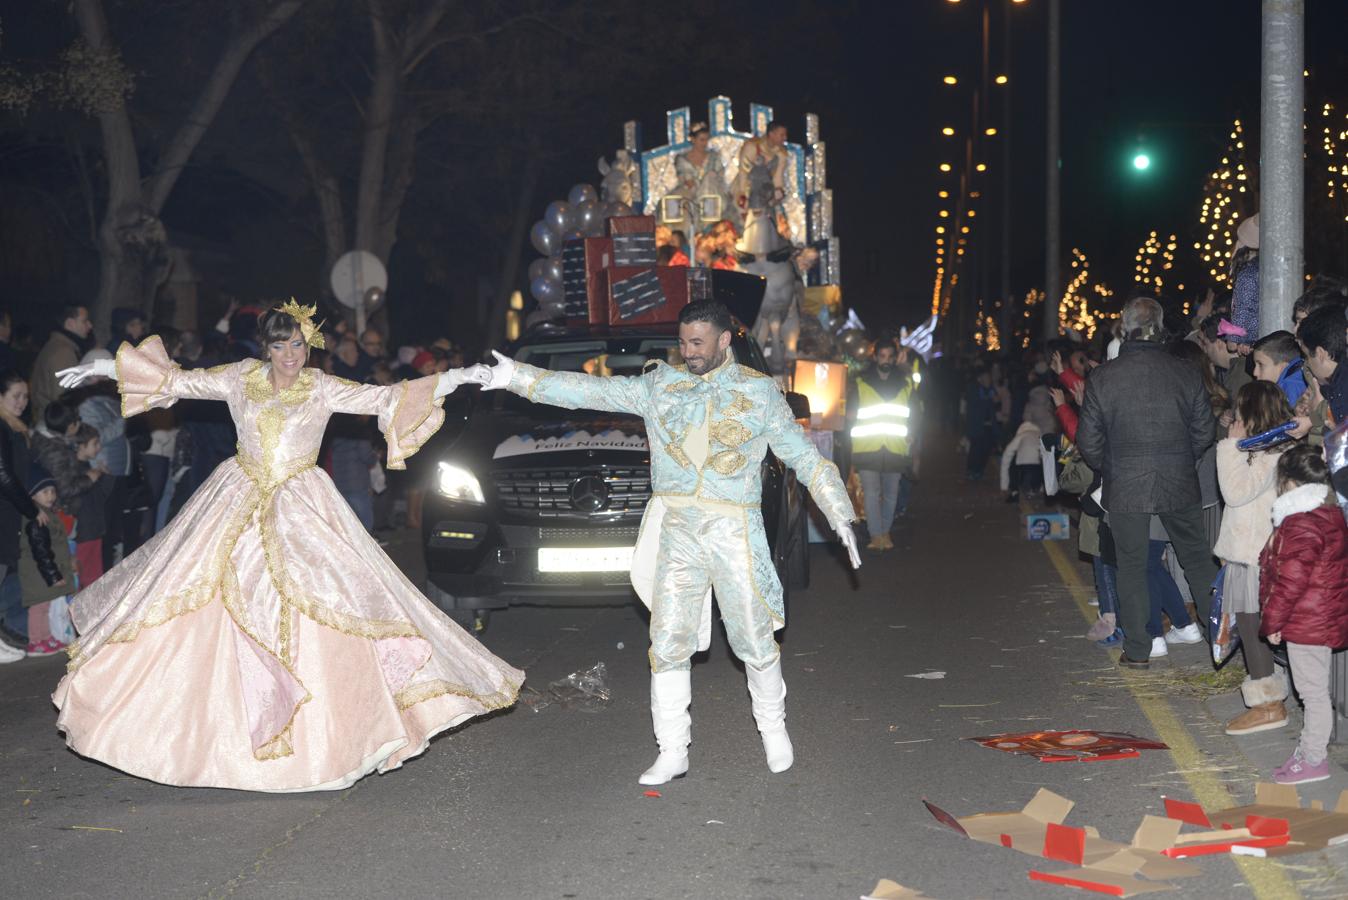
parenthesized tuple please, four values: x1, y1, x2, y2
(322, 375, 445, 469)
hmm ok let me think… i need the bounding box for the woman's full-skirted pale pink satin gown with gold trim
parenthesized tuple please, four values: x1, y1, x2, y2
(53, 337, 524, 791)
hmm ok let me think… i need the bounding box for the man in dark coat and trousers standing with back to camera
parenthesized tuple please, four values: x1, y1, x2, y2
(1077, 296, 1217, 668)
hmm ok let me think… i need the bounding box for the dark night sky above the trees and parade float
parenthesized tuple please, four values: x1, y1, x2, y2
(0, 0, 1348, 347)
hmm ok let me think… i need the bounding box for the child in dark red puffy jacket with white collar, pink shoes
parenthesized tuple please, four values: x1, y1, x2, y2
(1259, 445, 1348, 784)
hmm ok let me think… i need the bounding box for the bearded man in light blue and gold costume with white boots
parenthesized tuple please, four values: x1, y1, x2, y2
(473, 300, 861, 784)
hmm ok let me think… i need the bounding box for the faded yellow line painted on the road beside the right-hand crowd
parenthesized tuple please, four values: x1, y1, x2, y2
(1043, 540, 1301, 900)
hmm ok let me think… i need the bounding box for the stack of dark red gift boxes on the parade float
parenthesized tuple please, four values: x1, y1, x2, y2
(562, 216, 712, 325)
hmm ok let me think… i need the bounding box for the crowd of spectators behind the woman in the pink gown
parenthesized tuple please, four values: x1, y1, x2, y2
(0, 303, 464, 663)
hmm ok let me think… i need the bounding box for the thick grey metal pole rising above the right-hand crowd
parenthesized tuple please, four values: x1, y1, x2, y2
(1259, 0, 1306, 334)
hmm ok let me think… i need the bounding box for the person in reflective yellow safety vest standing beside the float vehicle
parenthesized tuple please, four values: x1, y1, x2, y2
(847, 340, 917, 550)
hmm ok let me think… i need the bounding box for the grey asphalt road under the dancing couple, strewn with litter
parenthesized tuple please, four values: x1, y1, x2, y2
(0, 463, 1348, 900)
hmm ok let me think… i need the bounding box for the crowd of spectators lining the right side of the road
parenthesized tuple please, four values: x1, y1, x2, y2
(964, 229, 1348, 783)
